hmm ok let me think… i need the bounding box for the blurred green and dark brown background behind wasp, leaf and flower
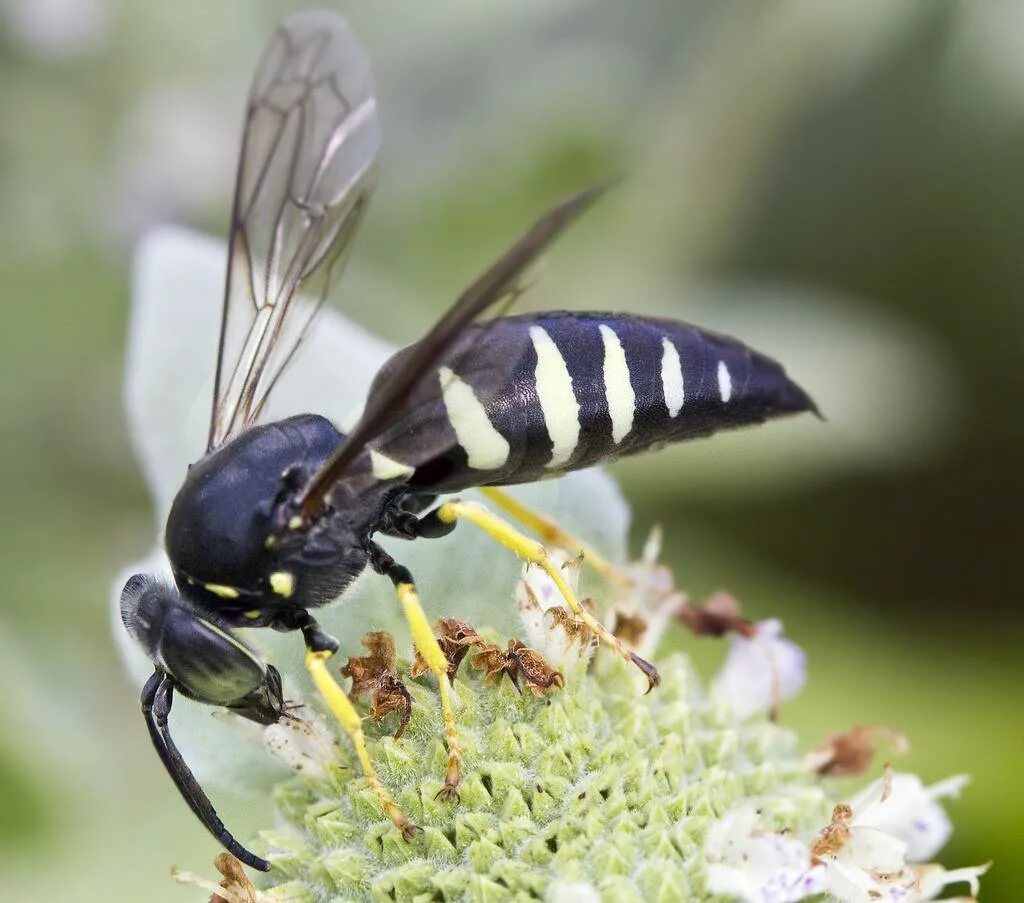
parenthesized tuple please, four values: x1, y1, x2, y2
(0, 0, 1024, 901)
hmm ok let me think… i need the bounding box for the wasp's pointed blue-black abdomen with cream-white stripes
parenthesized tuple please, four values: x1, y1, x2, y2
(388, 313, 816, 490)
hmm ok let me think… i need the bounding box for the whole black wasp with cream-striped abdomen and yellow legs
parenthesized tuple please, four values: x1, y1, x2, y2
(121, 7, 814, 869)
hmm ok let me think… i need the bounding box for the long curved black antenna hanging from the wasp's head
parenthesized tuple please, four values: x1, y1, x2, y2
(141, 671, 270, 871)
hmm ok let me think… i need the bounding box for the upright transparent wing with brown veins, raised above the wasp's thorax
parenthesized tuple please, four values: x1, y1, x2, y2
(207, 10, 380, 450)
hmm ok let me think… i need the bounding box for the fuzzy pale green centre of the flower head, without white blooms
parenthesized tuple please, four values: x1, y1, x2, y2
(251, 638, 831, 903)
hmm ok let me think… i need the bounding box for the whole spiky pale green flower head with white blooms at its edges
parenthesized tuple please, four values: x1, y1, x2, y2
(193, 548, 979, 903)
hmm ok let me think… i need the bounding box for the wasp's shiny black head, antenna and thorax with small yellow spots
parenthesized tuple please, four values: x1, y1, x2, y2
(121, 414, 451, 871)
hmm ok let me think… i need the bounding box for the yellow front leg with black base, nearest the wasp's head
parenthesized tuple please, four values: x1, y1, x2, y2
(273, 609, 420, 841)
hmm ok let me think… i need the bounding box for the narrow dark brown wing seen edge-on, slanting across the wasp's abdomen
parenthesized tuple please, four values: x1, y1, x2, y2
(301, 184, 605, 516)
